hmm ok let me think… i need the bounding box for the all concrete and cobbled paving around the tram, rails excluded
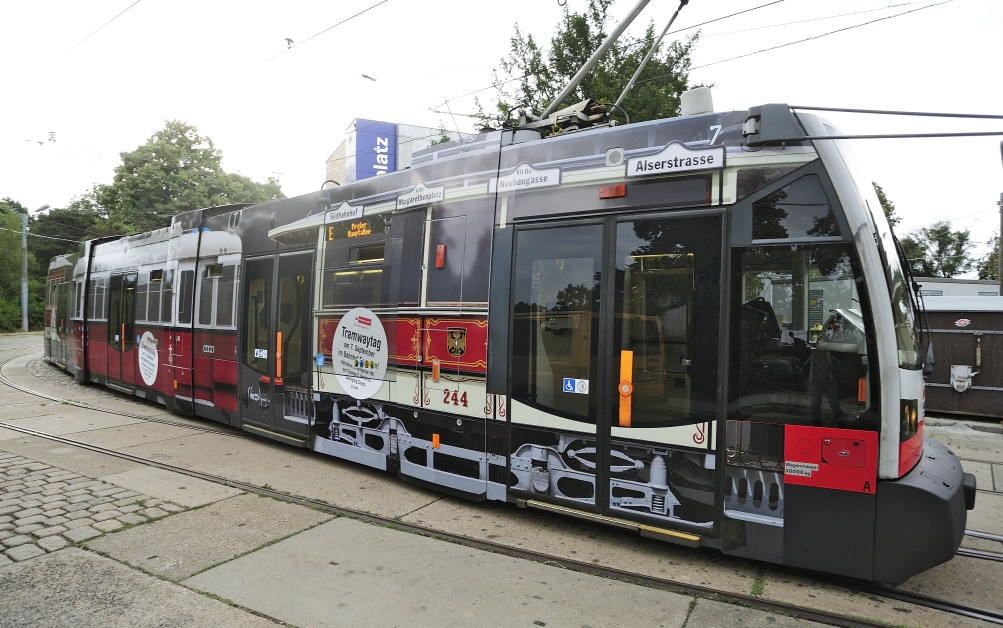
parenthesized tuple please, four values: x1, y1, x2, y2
(0, 337, 990, 628)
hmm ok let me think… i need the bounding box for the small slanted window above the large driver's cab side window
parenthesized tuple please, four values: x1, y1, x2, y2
(752, 175, 840, 241)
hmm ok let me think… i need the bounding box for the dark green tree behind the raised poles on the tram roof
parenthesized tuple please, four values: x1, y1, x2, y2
(485, 0, 699, 124)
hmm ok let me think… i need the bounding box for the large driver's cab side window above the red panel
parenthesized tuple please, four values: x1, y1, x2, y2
(728, 244, 878, 427)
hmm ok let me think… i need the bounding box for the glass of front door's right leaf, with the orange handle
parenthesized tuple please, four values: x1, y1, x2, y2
(613, 217, 721, 429)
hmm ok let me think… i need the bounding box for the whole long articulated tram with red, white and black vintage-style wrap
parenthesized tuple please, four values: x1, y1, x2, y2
(45, 104, 975, 583)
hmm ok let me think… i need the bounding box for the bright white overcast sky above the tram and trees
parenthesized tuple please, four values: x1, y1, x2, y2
(0, 0, 1003, 264)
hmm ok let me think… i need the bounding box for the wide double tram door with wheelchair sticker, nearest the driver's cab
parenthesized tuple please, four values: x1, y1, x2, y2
(510, 215, 722, 526)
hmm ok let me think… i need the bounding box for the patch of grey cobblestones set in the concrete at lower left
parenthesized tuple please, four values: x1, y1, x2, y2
(0, 451, 187, 567)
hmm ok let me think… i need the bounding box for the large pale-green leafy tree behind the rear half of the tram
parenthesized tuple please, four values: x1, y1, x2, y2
(96, 120, 284, 234)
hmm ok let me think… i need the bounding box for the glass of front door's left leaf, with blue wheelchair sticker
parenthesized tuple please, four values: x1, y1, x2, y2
(512, 225, 603, 424)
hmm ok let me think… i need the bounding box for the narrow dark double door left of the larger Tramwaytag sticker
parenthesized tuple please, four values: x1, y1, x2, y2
(239, 253, 313, 445)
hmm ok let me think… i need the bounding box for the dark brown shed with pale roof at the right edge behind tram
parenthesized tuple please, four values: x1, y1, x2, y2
(921, 296, 1003, 418)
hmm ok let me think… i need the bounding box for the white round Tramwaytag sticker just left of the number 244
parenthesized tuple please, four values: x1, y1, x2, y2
(331, 307, 387, 399)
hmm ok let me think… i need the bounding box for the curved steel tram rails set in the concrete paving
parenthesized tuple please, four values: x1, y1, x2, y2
(0, 357, 1003, 628)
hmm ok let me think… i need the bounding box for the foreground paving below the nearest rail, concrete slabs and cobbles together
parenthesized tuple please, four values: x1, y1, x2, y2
(0, 442, 813, 628)
